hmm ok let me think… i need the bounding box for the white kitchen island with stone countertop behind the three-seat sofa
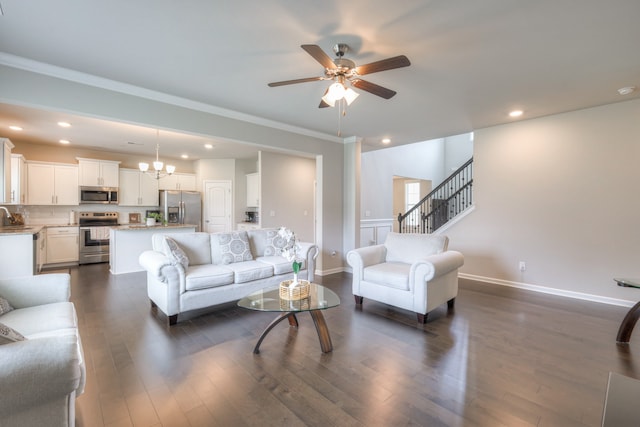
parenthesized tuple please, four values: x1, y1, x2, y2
(109, 224, 196, 274)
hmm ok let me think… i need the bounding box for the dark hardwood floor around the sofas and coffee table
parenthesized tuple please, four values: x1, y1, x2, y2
(71, 264, 640, 427)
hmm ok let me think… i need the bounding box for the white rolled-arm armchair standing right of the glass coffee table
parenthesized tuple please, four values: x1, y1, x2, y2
(347, 233, 464, 323)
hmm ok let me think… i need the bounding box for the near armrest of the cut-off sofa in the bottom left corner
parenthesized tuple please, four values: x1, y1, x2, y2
(0, 335, 81, 414)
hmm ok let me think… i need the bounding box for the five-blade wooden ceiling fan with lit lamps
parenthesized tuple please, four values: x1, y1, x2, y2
(269, 43, 411, 108)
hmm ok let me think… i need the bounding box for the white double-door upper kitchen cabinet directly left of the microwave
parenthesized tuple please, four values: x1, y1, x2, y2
(27, 162, 79, 206)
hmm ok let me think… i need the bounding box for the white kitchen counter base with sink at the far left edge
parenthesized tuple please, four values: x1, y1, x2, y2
(0, 225, 43, 279)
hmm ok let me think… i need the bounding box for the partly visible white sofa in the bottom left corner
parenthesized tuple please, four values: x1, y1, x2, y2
(0, 274, 86, 426)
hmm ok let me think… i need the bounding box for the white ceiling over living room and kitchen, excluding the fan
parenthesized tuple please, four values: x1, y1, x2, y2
(0, 0, 640, 159)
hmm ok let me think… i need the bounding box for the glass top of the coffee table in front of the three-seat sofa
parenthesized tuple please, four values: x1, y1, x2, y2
(238, 283, 340, 312)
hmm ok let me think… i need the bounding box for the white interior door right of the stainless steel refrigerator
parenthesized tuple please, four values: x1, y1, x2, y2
(204, 181, 233, 233)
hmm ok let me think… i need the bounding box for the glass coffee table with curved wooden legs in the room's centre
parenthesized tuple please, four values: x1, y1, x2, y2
(238, 283, 340, 354)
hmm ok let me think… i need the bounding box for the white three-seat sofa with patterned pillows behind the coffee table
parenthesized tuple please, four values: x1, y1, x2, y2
(139, 228, 318, 325)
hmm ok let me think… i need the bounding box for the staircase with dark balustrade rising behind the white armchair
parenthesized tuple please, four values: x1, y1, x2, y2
(398, 157, 473, 234)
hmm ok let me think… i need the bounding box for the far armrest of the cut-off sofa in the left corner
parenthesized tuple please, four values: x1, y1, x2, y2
(0, 273, 71, 308)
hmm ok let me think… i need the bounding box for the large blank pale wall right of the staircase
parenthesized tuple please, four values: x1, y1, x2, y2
(446, 100, 640, 301)
